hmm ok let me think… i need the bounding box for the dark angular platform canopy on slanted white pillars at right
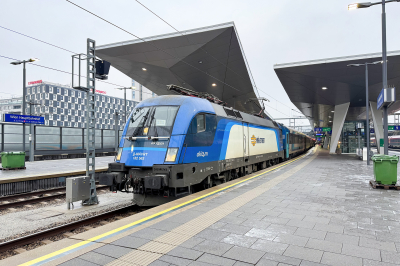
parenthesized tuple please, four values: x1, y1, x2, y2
(274, 51, 400, 127)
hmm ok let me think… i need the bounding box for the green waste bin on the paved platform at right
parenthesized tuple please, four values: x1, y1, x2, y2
(371, 154, 399, 185)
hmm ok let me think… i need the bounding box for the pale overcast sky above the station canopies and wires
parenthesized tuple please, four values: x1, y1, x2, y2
(0, 0, 400, 128)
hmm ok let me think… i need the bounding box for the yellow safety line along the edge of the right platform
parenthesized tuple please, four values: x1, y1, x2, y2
(20, 150, 315, 266)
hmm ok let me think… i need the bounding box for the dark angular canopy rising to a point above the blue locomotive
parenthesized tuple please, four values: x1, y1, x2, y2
(96, 22, 261, 116)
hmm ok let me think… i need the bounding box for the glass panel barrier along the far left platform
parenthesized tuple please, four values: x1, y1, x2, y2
(0, 123, 122, 155)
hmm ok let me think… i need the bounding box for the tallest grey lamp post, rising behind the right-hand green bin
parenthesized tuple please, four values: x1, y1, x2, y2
(348, 0, 400, 155)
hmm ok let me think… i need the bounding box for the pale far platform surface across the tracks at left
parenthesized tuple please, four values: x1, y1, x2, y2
(0, 156, 115, 184)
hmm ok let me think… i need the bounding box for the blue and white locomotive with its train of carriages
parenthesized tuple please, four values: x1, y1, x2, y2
(99, 90, 315, 206)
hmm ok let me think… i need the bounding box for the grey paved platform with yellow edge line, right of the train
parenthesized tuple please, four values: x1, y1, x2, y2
(0, 148, 400, 266)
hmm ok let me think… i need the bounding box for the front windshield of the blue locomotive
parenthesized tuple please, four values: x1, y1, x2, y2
(126, 106, 179, 137)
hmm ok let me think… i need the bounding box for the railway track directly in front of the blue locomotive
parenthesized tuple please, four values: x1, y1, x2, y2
(0, 205, 141, 253)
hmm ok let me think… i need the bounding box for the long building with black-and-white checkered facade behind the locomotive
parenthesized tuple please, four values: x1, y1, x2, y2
(24, 80, 138, 129)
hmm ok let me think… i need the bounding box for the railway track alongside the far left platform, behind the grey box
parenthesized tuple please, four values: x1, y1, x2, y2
(0, 186, 109, 210)
